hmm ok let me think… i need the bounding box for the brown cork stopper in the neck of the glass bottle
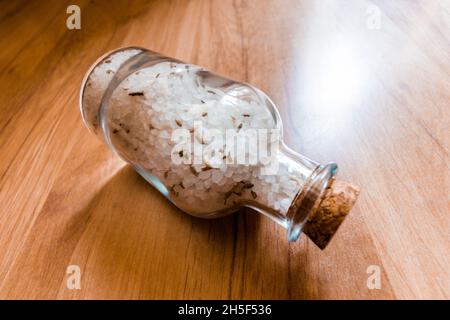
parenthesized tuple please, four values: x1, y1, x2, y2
(303, 180, 359, 249)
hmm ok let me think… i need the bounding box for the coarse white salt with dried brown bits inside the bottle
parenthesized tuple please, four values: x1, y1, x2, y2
(83, 49, 306, 216)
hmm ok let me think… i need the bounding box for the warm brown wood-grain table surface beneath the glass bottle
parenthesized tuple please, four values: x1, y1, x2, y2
(0, 0, 450, 299)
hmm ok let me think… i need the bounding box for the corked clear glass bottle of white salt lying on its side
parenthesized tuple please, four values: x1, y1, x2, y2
(80, 47, 359, 249)
